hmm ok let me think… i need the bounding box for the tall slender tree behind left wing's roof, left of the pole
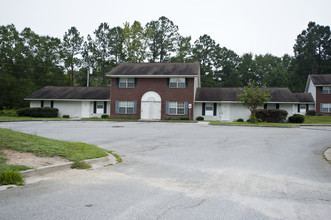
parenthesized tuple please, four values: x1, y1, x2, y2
(62, 27, 84, 86)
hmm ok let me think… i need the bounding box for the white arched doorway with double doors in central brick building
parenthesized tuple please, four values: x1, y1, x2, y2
(140, 91, 161, 120)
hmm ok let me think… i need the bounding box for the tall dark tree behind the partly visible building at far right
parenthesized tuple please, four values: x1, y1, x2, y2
(292, 22, 331, 91)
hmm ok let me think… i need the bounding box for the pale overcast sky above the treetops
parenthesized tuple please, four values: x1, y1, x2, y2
(0, 0, 331, 56)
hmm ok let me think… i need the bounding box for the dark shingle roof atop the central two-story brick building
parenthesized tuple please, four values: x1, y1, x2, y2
(107, 63, 200, 77)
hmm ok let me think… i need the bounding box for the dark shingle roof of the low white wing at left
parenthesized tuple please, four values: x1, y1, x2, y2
(25, 86, 110, 100)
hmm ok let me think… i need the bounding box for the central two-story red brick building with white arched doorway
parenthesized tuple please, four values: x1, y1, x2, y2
(107, 63, 200, 120)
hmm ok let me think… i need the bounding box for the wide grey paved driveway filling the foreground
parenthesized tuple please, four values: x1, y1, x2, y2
(0, 121, 331, 219)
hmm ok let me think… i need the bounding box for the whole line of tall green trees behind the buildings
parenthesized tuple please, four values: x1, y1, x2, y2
(0, 16, 331, 109)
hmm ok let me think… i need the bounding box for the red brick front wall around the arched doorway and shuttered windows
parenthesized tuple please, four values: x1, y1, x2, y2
(110, 78, 194, 119)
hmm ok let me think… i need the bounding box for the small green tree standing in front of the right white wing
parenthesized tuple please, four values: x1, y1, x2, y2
(238, 81, 270, 123)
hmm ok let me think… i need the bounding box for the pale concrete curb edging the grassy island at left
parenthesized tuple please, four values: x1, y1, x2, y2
(20, 154, 116, 177)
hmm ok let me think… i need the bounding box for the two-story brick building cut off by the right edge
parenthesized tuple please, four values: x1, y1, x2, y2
(305, 74, 331, 115)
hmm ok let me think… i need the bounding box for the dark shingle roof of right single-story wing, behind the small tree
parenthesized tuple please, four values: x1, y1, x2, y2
(195, 88, 298, 103)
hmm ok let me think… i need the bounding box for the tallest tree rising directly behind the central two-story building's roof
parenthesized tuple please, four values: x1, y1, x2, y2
(146, 16, 180, 63)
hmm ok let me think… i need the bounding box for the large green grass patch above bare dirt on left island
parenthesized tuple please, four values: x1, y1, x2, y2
(0, 129, 107, 161)
